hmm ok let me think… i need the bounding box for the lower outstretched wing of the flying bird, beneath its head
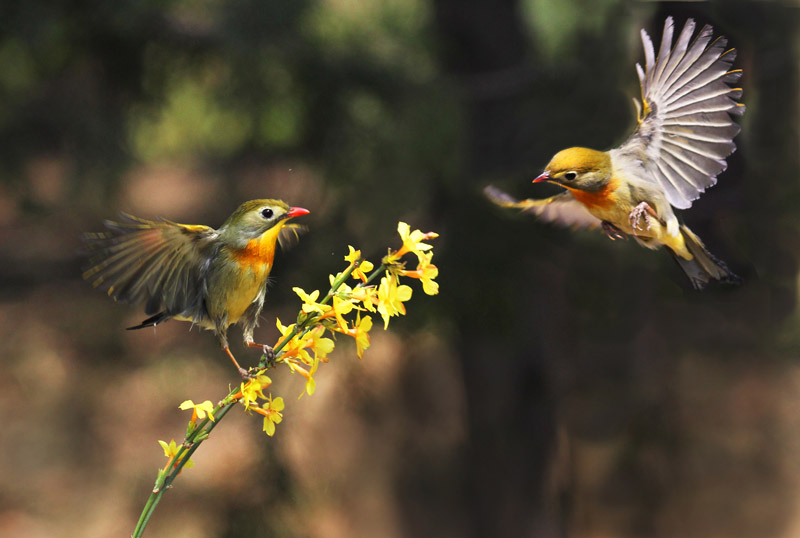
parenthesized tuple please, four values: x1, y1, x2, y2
(483, 185, 601, 228)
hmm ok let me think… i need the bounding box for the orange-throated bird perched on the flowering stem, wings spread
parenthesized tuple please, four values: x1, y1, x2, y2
(83, 200, 308, 376)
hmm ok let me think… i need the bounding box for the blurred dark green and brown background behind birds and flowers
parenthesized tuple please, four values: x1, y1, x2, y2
(0, 0, 800, 538)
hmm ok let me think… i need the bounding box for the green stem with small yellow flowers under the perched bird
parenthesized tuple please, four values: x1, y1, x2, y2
(133, 222, 439, 538)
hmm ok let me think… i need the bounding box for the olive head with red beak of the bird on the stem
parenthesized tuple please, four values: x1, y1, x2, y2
(219, 199, 309, 246)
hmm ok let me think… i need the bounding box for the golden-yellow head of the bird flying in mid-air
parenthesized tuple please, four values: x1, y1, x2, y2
(533, 148, 611, 192)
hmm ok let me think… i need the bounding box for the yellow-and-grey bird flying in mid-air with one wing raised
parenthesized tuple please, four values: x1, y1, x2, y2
(485, 17, 744, 289)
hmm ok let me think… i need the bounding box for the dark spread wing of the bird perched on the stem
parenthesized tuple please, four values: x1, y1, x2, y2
(83, 214, 217, 316)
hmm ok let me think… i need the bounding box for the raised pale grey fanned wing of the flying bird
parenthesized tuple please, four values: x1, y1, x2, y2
(614, 17, 744, 209)
